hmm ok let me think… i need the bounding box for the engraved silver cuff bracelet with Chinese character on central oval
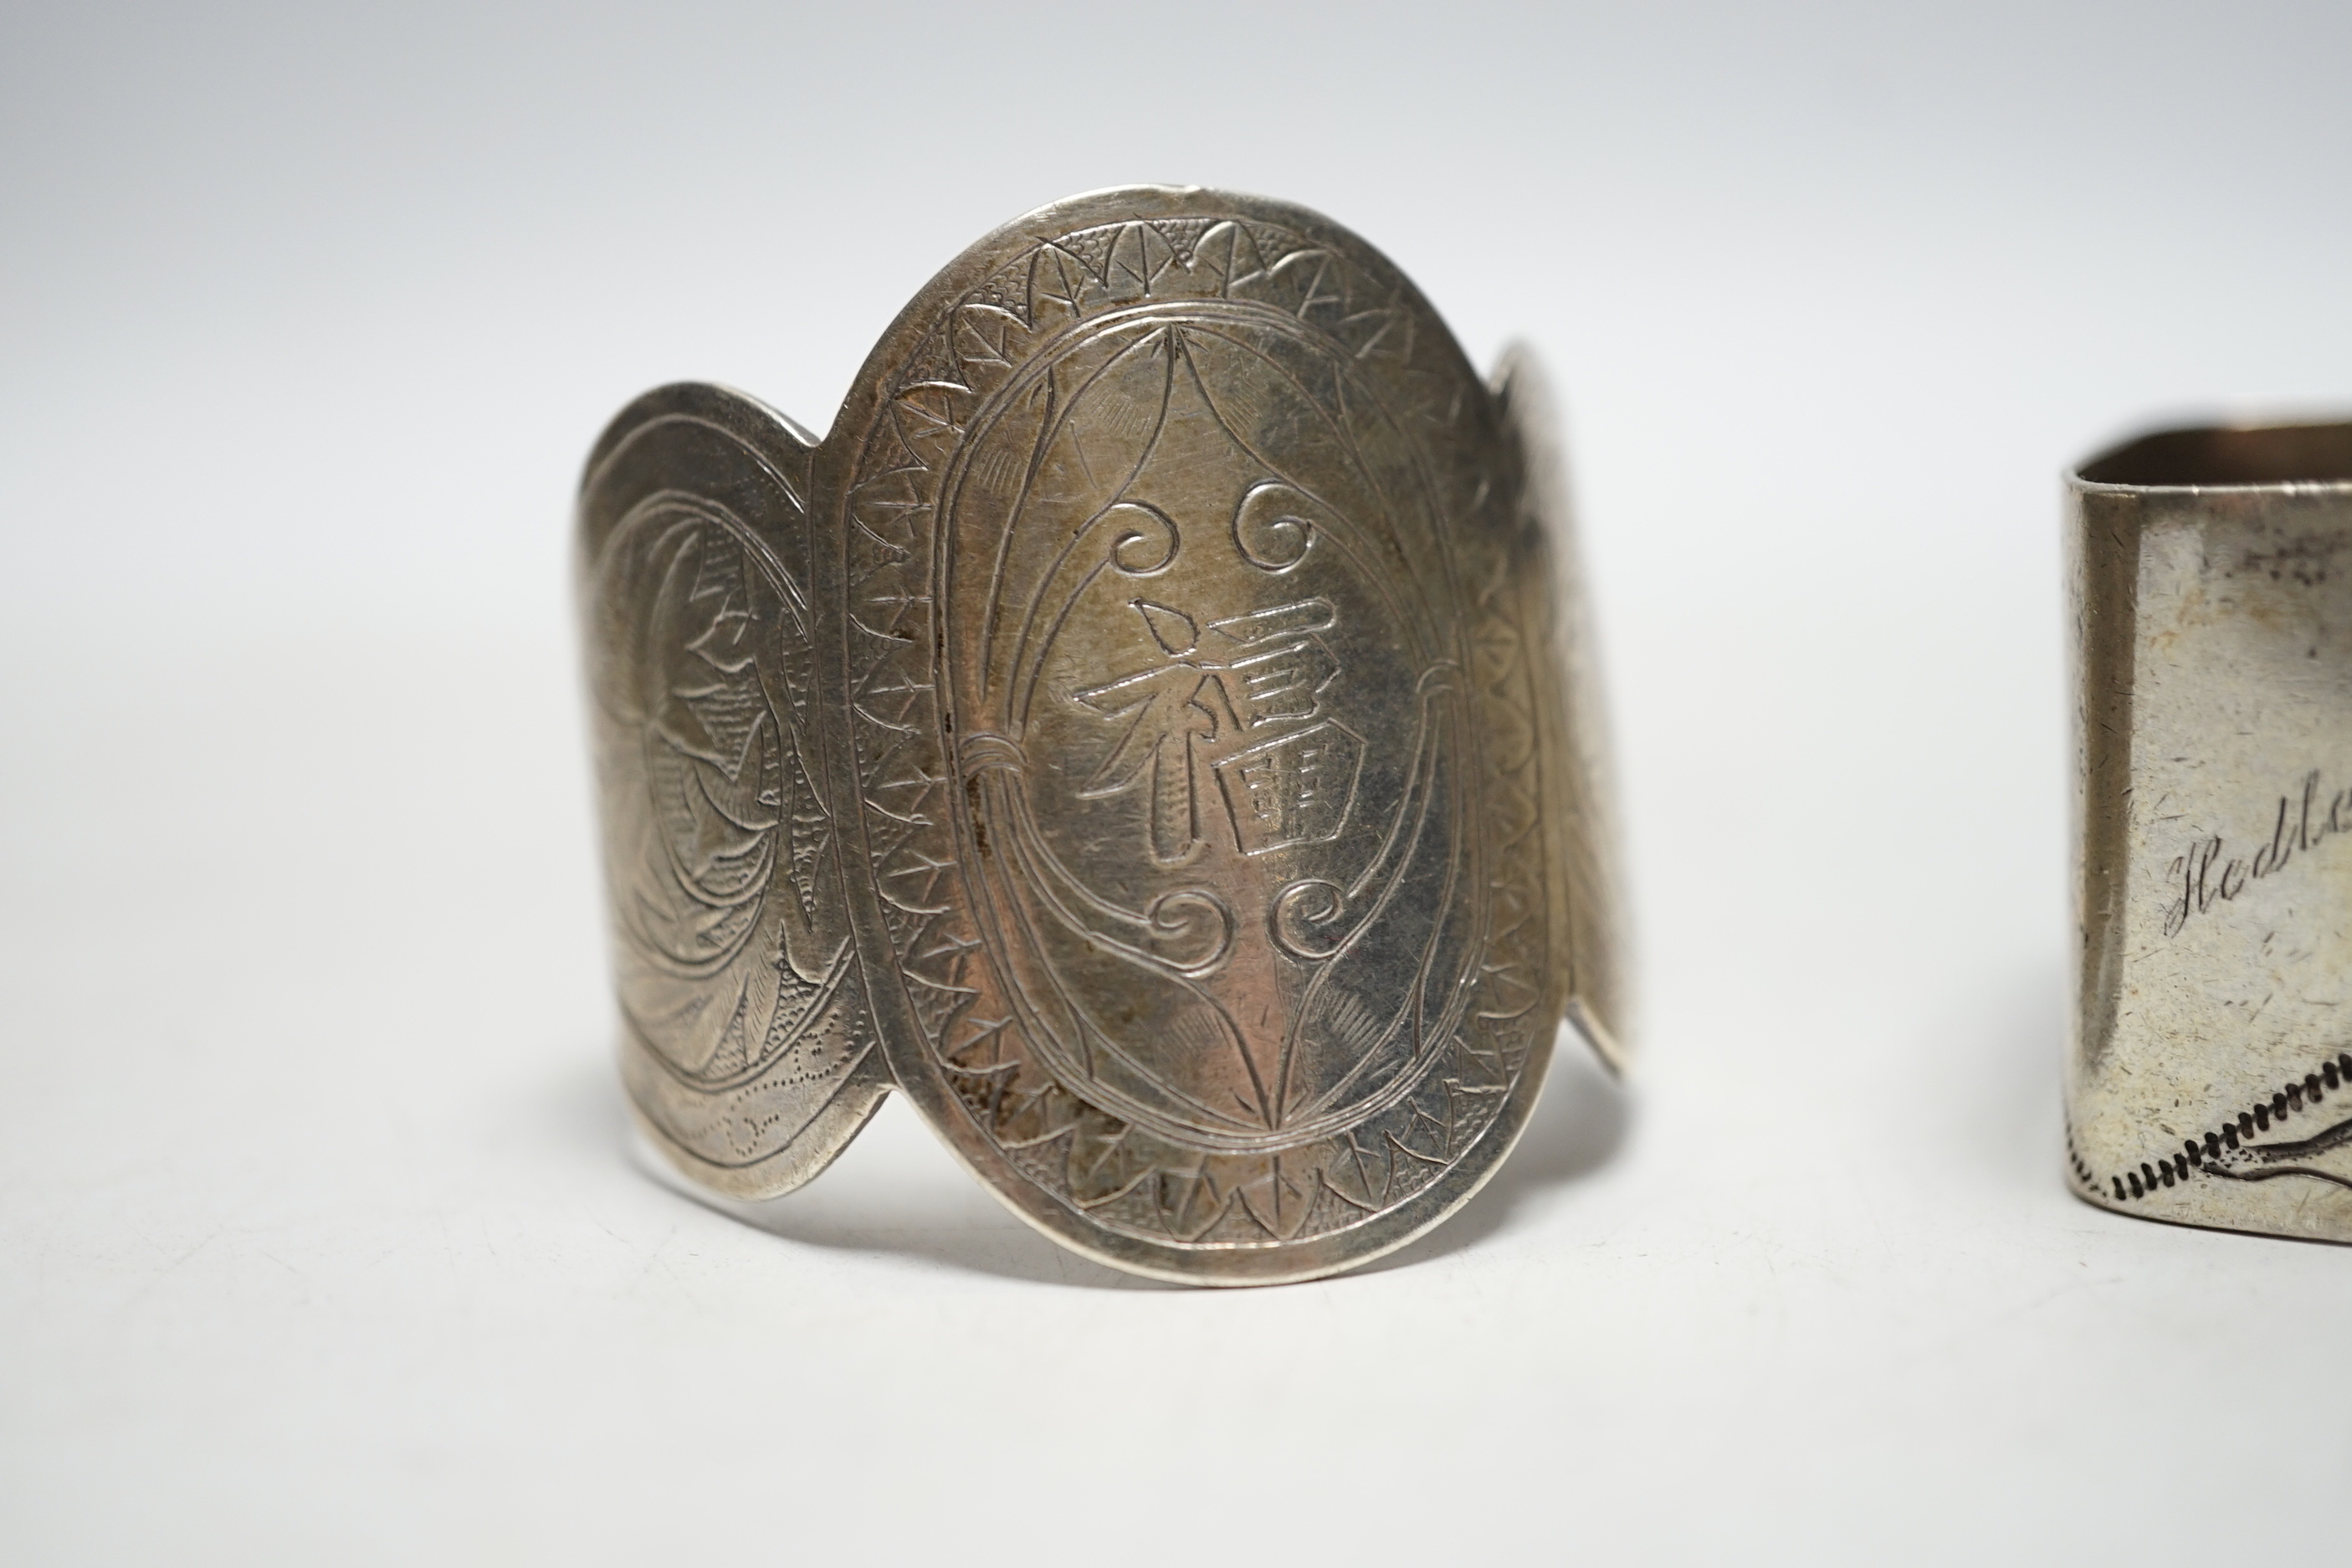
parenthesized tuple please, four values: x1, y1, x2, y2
(588, 188, 1621, 1284)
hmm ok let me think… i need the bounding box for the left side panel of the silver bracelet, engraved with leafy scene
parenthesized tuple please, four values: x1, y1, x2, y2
(579, 386, 889, 1199)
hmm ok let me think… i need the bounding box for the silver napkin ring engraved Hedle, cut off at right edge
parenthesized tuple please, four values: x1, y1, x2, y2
(2068, 423, 2352, 1241)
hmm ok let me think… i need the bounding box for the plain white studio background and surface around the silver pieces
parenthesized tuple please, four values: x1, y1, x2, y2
(0, 0, 2352, 1563)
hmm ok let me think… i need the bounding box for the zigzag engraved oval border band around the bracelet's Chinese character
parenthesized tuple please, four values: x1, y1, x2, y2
(847, 216, 1548, 1246)
